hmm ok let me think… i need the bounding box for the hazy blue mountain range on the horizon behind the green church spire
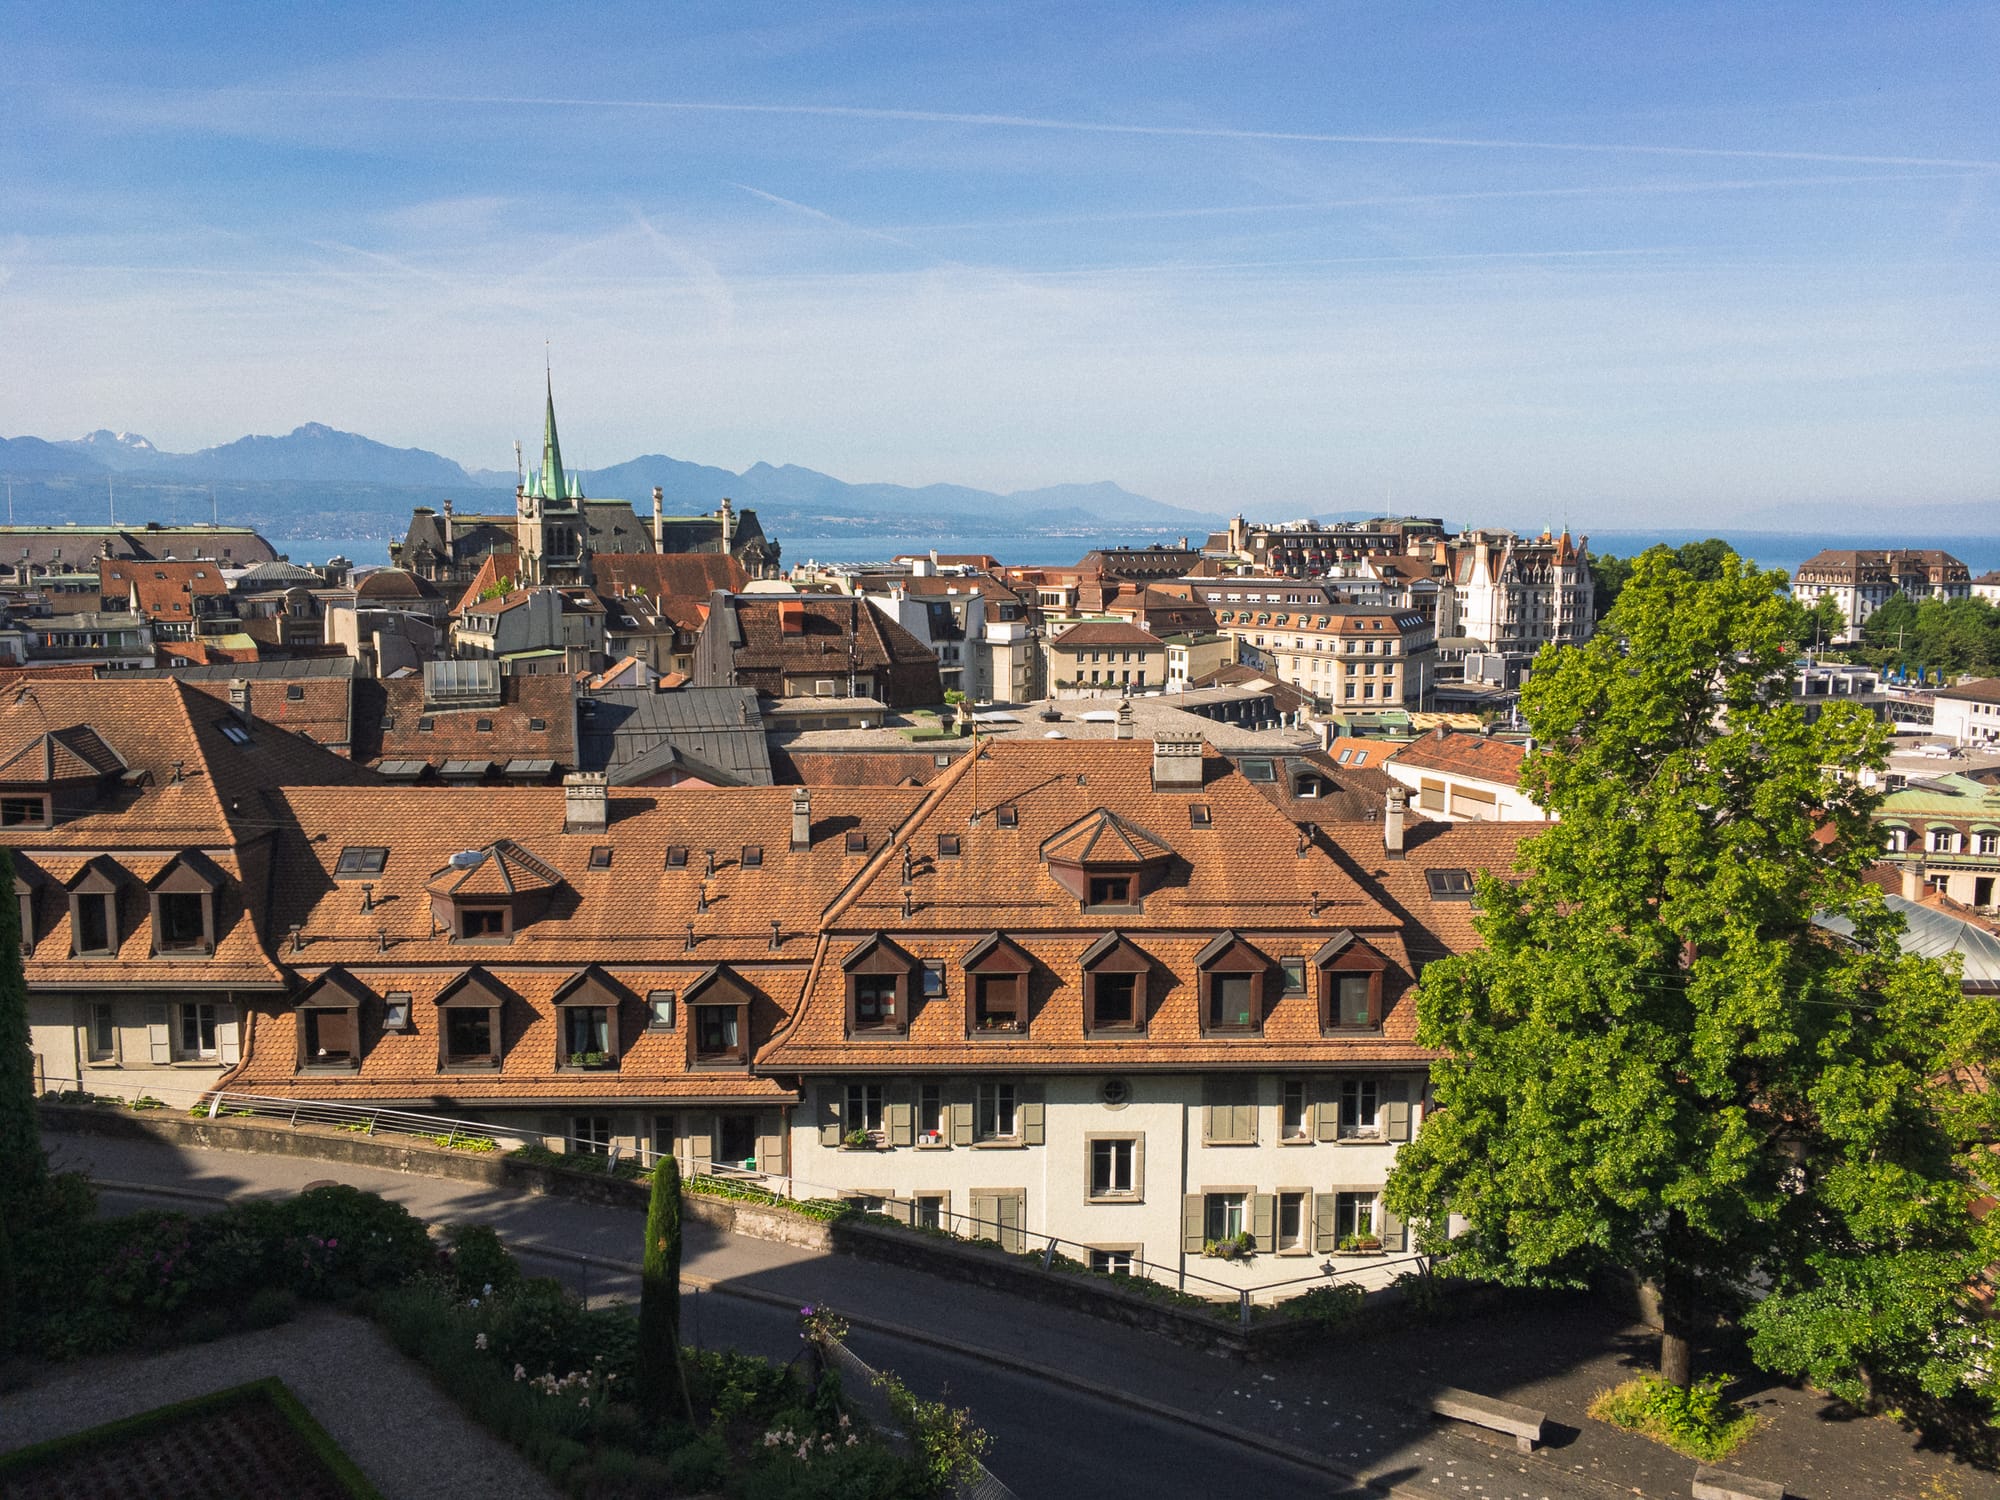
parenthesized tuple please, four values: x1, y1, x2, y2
(0, 422, 1220, 534)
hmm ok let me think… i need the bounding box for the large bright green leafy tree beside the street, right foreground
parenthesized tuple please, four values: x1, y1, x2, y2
(1388, 550, 2000, 1396)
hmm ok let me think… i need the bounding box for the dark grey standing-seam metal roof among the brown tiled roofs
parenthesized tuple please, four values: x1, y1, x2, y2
(576, 688, 772, 786)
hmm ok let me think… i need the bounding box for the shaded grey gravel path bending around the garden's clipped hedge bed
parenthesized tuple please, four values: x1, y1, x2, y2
(0, 1310, 558, 1500)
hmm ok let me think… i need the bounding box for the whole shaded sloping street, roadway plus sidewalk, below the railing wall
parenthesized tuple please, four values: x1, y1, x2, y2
(48, 1136, 2000, 1500)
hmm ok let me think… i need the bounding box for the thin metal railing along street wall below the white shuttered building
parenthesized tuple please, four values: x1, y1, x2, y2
(43, 1080, 1428, 1328)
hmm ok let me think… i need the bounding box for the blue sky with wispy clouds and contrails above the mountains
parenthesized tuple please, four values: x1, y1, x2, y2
(0, 0, 2000, 528)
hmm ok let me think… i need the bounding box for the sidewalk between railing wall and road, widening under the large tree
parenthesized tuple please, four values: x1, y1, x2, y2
(48, 1136, 2000, 1500)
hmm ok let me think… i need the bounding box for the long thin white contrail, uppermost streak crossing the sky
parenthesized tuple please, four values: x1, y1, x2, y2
(105, 88, 2000, 172)
